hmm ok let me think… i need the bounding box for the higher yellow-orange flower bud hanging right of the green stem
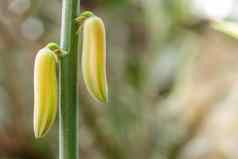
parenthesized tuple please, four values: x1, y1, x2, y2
(82, 16, 108, 103)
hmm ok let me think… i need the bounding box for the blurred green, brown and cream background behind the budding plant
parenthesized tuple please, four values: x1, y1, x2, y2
(0, 0, 238, 159)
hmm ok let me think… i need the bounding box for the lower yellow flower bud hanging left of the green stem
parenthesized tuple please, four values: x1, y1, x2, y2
(34, 47, 58, 138)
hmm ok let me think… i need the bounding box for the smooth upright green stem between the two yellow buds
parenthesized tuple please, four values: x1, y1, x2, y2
(59, 0, 80, 159)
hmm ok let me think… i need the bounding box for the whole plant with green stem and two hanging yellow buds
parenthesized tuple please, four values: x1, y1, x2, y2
(34, 0, 108, 159)
